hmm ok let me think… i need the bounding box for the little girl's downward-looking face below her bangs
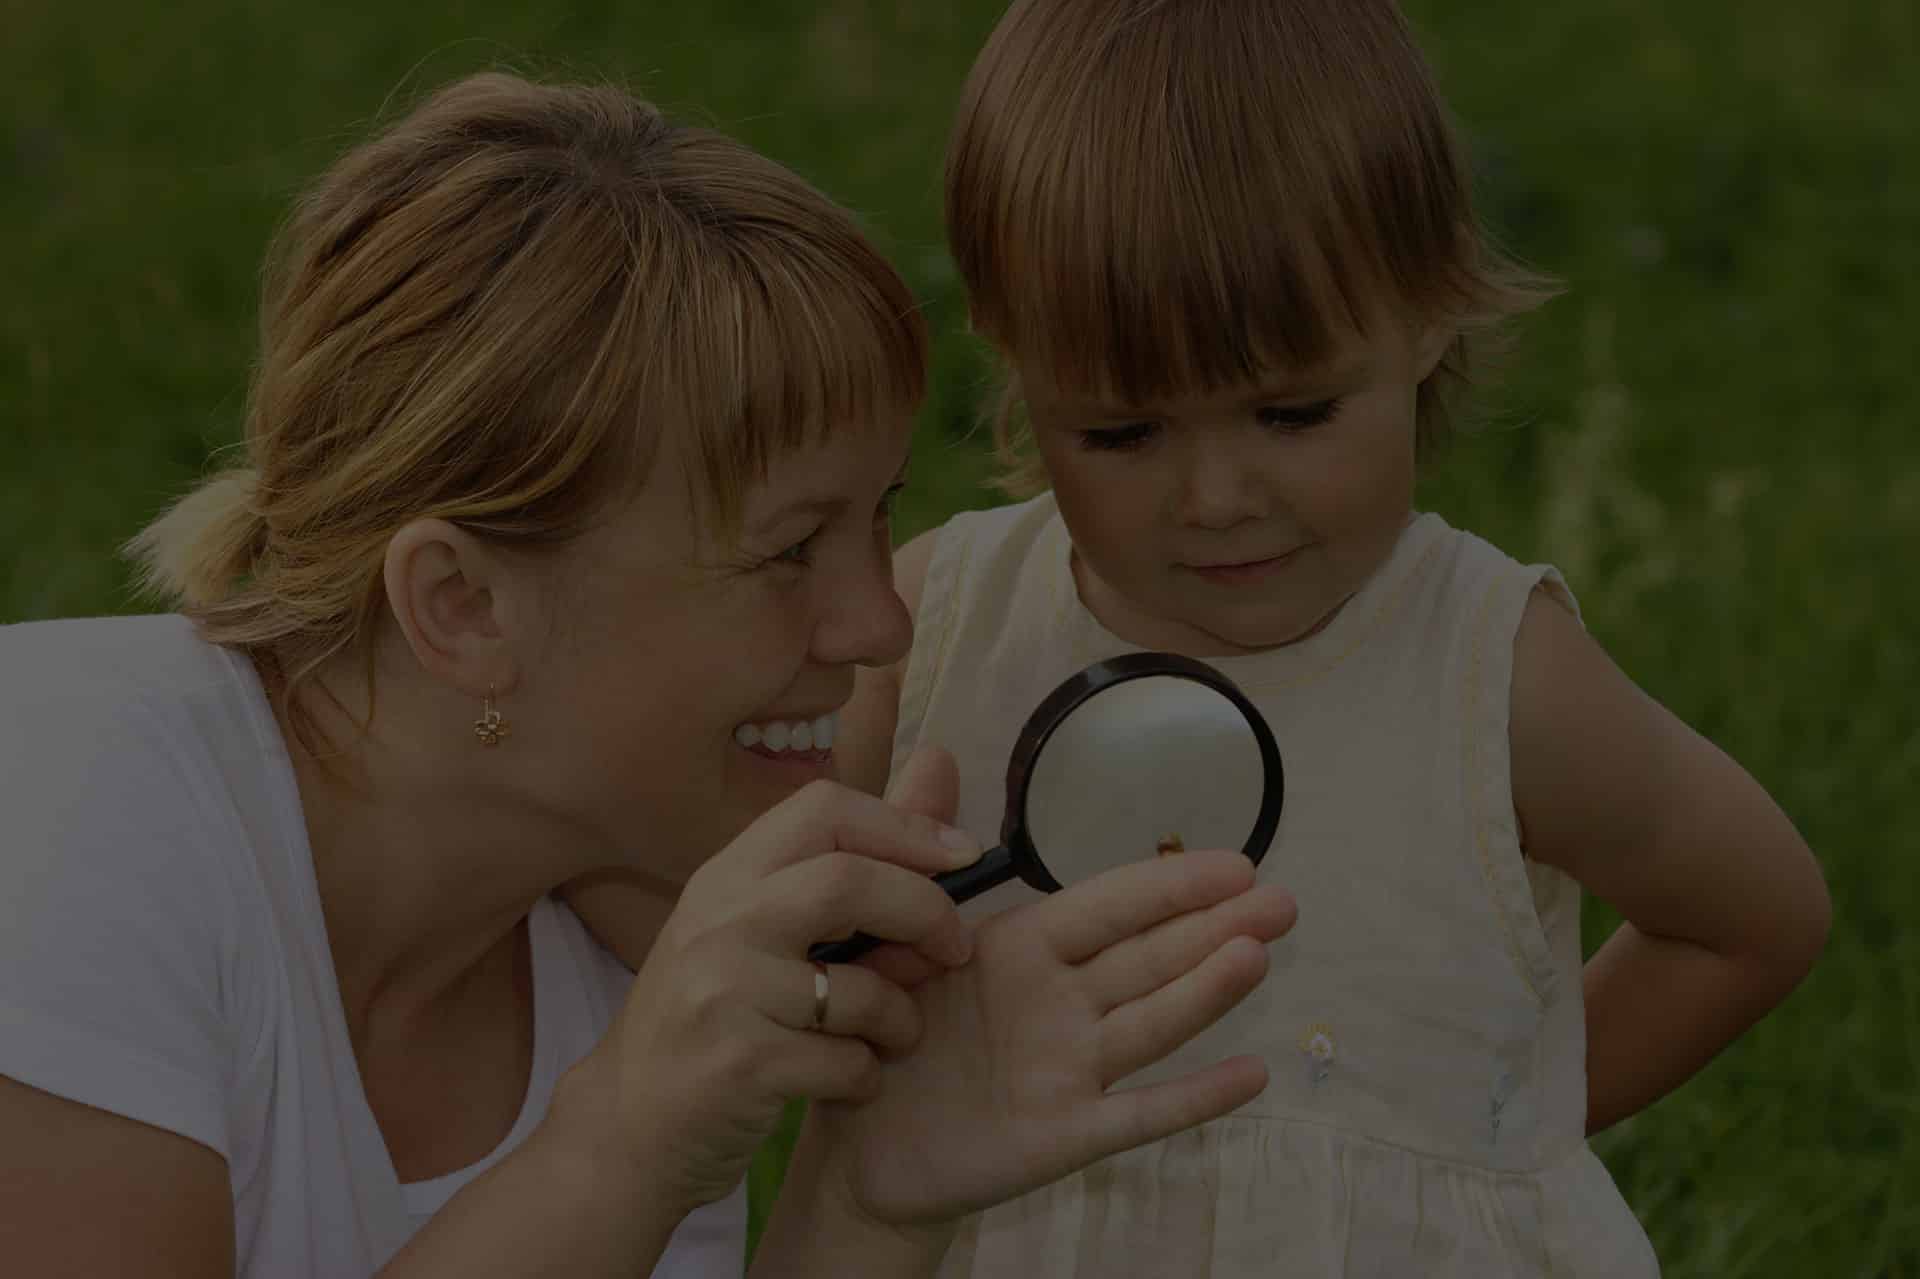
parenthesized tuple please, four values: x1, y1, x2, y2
(1016, 318, 1446, 657)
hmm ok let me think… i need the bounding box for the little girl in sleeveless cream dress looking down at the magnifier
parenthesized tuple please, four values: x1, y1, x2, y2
(839, 0, 1828, 1279)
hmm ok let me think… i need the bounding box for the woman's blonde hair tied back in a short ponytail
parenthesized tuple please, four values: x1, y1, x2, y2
(129, 73, 925, 745)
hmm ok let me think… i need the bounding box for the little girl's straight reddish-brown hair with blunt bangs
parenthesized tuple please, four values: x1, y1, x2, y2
(947, 0, 1553, 495)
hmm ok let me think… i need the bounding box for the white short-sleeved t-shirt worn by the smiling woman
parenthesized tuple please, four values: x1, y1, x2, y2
(0, 616, 747, 1279)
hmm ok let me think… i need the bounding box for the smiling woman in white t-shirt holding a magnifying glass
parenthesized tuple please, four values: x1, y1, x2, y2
(0, 75, 1292, 1277)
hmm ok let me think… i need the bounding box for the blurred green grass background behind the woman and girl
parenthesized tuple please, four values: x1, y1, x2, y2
(0, 0, 1920, 1277)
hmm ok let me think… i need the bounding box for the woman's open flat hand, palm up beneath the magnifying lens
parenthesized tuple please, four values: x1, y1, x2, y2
(804, 853, 1294, 1231)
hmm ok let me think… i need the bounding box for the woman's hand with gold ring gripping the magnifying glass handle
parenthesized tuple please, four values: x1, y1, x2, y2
(555, 782, 979, 1210)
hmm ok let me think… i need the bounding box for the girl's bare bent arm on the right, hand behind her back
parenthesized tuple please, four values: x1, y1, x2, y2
(1509, 591, 1830, 1133)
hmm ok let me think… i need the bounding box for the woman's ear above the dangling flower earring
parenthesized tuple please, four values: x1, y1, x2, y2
(382, 520, 524, 699)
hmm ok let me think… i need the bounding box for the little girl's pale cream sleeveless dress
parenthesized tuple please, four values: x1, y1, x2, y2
(893, 497, 1659, 1279)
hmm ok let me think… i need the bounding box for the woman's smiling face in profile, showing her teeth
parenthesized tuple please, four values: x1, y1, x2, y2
(503, 412, 912, 885)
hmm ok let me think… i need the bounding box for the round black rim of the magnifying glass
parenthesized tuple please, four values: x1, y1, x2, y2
(1000, 653, 1286, 893)
